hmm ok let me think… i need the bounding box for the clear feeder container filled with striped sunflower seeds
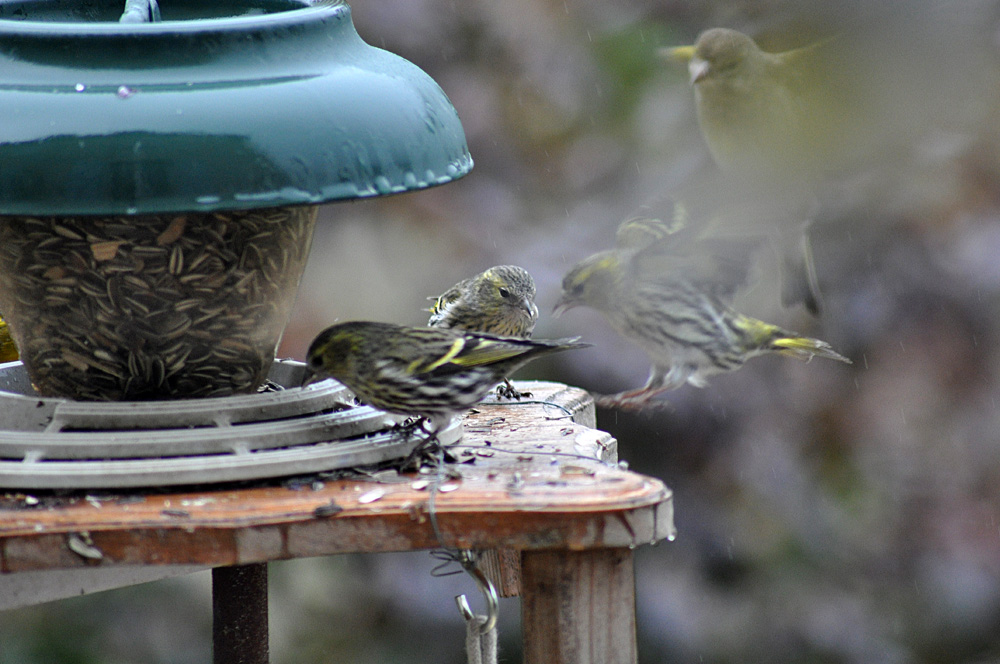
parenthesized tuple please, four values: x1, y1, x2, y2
(0, 207, 316, 401)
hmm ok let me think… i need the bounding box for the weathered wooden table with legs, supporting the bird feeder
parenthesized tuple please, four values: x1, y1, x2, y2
(0, 382, 673, 664)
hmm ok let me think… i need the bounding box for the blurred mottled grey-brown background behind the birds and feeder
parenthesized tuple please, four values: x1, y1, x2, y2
(0, 0, 1000, 664)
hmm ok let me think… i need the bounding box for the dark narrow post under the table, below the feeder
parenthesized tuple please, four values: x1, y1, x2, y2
(212, 563, 269, 664)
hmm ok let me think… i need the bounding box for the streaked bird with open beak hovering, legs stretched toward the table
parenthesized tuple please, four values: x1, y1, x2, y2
(556, 222, 850, 405)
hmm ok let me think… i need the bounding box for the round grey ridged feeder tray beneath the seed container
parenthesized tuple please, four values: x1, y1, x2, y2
(0, 360, 462, 489)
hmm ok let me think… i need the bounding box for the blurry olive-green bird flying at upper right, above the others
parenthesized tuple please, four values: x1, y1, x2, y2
(662, 28, 857, 313)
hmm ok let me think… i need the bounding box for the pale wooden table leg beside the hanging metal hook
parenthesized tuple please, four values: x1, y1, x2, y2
(521, 549, 637, 664)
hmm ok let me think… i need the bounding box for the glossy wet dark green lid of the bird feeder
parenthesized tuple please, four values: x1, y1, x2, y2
(0, 0, 472, 216)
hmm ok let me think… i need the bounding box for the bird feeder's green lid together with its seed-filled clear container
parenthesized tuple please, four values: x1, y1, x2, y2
(0, 0, 472, 401)
